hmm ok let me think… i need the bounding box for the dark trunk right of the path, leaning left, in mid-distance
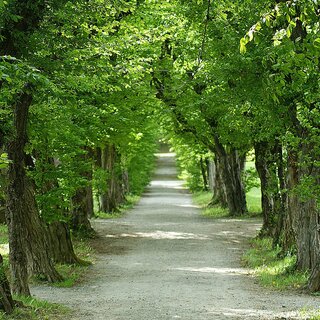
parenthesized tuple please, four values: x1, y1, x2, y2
(215, 136, 248, 216)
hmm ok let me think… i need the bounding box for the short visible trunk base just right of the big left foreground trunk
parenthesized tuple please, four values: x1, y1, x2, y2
(48, 221, 80, 264)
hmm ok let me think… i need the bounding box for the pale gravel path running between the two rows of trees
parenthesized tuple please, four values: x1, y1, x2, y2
(32, 154, 320, 320)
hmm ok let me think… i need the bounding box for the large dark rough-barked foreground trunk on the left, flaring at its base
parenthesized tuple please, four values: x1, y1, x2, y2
(6, 88, 62, 295)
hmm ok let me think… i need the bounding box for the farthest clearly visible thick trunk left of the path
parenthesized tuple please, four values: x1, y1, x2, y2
(99, 144, 124, 212)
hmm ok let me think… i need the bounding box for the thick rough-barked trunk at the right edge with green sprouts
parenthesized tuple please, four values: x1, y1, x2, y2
(288, 109, 320, 291)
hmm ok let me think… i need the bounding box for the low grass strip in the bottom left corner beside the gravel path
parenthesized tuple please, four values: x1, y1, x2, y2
(0, 296, 71, 320)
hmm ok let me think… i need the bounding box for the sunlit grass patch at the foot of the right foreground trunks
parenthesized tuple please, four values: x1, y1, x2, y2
(242, 238, 308, 290)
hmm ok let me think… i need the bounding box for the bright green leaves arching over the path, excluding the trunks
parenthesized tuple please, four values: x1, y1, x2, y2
(0, 0, 320, 298)
